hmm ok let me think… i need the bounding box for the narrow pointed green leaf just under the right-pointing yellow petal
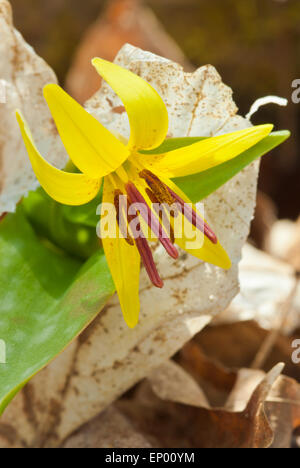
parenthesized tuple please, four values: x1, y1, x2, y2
(174, 130, 290, 203)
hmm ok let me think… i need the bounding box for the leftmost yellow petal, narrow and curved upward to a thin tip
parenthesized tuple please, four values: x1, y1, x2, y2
(16, 111, 101, 205)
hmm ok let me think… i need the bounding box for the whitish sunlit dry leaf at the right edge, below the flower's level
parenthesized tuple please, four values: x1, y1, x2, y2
(214, 244, 300, 334)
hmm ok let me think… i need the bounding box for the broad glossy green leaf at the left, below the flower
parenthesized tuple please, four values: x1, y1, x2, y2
(0, 207, 115, 413)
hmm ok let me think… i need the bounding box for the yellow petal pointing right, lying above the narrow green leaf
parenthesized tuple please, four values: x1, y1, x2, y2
(146, 125, 273, 178)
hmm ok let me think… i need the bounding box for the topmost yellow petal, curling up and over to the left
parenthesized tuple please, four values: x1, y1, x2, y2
(92, 58, 169, 149)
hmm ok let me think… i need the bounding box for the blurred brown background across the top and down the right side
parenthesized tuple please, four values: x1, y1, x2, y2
(11, 0, 300, 236)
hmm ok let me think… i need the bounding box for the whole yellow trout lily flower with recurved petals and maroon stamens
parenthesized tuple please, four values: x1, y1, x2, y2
(17, 58, 272, 327)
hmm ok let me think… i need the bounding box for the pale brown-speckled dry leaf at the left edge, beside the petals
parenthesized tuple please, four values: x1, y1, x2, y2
(0, 0, 68, 213)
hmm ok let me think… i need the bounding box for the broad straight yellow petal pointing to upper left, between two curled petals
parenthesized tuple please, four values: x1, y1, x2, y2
(44, 84, 129, 179)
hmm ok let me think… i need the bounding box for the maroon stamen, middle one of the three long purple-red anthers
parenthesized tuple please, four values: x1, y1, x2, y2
(126, 182, 179, 259)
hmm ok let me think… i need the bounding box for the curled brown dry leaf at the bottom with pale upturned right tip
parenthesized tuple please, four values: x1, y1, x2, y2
(117, 364, 284, 448)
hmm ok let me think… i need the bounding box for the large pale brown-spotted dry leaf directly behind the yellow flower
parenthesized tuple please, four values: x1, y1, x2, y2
(3, 39, 258, 445)
